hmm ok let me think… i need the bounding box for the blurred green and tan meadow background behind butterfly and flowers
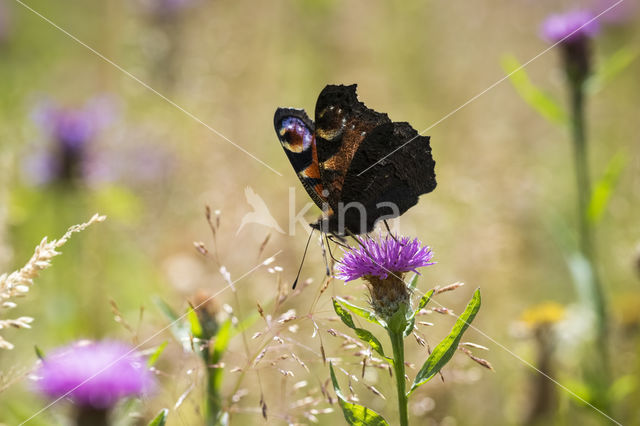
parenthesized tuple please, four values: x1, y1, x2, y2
(0, 0, 640, 425)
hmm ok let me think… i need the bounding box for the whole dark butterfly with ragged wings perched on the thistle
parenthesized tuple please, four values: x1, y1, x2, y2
(274, 84, 436, 235)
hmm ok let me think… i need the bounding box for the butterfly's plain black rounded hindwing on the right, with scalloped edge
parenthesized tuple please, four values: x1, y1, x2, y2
(341, 122, 436, 234)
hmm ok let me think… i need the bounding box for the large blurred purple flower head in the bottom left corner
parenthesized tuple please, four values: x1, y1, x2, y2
(37, 341, 153, 410)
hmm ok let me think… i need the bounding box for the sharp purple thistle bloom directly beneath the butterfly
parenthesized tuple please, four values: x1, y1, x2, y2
(337, 236, 435, 281)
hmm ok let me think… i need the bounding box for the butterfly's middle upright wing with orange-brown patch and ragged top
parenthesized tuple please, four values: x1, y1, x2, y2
(315, 84, 391, 210)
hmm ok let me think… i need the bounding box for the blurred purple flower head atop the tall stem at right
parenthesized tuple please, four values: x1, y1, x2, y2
(541, 10, 600, 43)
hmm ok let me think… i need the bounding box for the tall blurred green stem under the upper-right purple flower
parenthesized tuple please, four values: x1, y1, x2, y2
(571, 81, 609, 400)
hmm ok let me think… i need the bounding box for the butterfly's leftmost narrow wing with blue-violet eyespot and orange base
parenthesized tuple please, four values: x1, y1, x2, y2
(273, 108, 327, 208)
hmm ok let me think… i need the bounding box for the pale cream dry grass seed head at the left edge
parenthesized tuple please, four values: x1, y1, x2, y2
(0, 213, 106, 349)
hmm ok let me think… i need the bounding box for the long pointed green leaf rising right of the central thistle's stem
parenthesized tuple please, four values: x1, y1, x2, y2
(409, 290, 481, 394)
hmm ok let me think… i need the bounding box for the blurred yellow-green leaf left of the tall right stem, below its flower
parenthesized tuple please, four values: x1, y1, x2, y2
(502, 55, 568, 126)
